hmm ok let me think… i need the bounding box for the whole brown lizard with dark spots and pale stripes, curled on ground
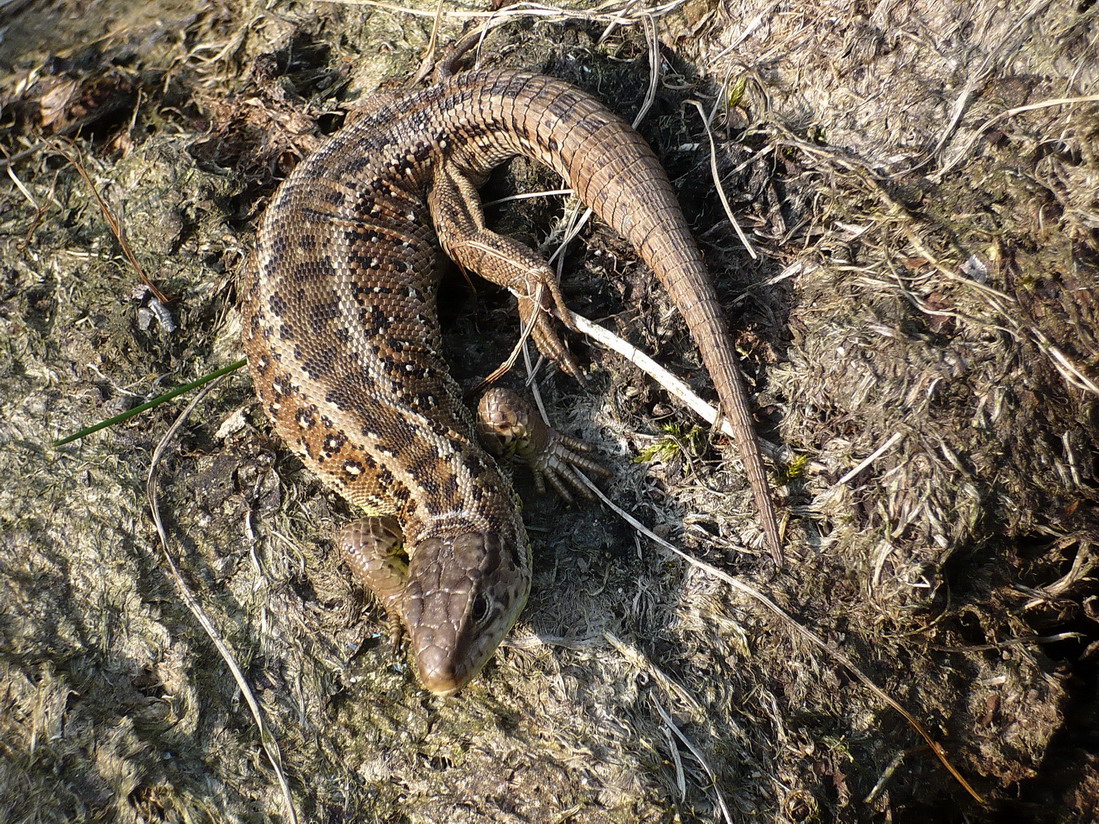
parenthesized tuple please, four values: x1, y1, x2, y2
(240, 61, 780, 697)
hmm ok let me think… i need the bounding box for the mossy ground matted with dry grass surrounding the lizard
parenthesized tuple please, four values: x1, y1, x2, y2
(0, 0, 1099, 822)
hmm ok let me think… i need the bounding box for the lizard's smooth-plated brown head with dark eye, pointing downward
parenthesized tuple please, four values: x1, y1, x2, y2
(404, 527, 531, 697)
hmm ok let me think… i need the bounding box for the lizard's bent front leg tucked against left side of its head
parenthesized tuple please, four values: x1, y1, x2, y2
(336, 516, 409, 648)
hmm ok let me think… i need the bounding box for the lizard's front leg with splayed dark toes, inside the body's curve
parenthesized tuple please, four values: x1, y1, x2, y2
(477, 387, 611, 503)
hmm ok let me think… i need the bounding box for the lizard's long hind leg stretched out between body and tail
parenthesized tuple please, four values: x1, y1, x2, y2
(428, 165, 582, 380)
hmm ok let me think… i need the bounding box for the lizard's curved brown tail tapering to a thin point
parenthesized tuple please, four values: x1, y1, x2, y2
(468, 73, 781, 564)
